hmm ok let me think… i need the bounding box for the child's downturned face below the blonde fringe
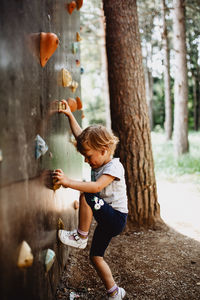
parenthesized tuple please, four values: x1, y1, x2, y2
(84, 147, 110, 169)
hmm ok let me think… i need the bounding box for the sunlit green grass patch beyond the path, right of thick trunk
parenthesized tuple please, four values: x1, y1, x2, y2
(151, 132, 200, 181)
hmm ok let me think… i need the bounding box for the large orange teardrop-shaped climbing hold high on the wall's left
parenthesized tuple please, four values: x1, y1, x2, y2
(40, 32, 59, 67)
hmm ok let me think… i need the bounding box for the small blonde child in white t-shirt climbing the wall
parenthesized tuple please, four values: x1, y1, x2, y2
(53, 100, 128, 300)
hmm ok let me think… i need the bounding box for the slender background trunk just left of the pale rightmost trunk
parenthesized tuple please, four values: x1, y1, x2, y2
(162, 0, 172, 140)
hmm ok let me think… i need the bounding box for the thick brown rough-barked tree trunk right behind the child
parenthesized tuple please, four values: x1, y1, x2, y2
(104, 0, 161, 227)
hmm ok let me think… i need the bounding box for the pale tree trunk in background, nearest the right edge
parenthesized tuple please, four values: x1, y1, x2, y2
(173, 0, 189, 157)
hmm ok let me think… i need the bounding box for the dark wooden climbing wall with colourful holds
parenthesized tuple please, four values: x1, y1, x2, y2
(0, 0, 82, 300)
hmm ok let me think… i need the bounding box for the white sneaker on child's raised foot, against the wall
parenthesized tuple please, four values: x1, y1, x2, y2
(58, 229, 88, 249)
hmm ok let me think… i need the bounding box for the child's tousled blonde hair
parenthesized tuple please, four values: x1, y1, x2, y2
(76, 125, 119, 155)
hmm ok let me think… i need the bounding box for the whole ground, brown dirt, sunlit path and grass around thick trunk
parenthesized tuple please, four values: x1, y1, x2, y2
(56, 133, 200, 300)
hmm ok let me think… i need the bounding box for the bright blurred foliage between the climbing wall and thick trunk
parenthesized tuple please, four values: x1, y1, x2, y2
(80, 0, 105, 124)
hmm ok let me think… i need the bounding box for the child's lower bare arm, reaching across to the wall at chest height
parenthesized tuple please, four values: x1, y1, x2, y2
(53, 169, 115, 193)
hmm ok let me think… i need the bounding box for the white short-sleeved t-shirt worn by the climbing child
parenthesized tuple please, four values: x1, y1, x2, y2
(92, 158, 128, 213)
